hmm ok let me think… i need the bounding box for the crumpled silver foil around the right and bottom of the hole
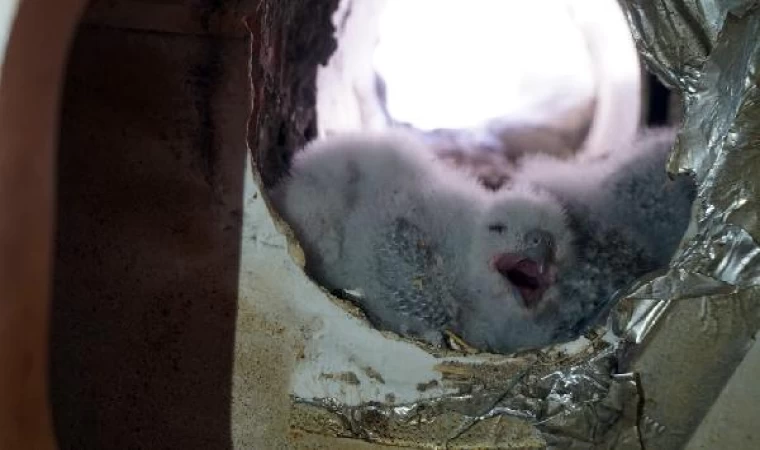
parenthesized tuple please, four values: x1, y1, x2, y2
(293, 0, 760, 449)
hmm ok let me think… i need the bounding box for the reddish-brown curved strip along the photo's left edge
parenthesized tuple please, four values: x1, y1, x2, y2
(0, 0, 84, 450)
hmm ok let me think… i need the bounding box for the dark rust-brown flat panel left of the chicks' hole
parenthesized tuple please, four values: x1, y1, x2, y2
(51, 1, 250, 450)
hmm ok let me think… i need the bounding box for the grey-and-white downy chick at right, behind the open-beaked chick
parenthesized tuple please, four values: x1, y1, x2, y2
(514, 128, 696, 339)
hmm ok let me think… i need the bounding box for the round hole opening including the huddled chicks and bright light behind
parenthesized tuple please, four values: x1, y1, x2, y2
(273, 0, 695, 354)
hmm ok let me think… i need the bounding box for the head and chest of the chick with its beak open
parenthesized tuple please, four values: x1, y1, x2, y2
(456, 186, 574, 353)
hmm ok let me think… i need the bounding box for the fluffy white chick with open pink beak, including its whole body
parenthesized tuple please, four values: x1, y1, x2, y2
(271, 131, 572, 352)
